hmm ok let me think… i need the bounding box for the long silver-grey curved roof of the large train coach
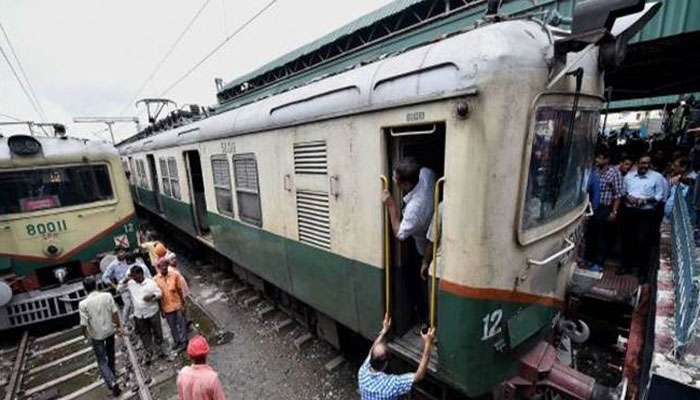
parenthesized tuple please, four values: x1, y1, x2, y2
(117, 19, 552, 153)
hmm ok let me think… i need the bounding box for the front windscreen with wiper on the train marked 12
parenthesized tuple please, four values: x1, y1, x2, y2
(522, 106, 599, 230)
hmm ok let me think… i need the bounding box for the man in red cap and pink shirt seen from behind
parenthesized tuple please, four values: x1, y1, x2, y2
(177, 335, 226, 400)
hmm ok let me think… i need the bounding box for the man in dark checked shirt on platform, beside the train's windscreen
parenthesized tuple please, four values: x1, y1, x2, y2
(586, 149, 623, 269)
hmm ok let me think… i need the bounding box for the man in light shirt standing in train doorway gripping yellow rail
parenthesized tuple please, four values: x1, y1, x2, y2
(382, 157, 435, 330)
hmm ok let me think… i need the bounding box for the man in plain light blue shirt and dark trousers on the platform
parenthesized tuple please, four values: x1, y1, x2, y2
(618, 154, 666, 283)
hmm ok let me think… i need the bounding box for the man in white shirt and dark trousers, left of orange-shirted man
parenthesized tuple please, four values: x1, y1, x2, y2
(118, 265, 165, 364)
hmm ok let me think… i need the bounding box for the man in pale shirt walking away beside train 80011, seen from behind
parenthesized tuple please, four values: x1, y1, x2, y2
(78, 276, 122, 396)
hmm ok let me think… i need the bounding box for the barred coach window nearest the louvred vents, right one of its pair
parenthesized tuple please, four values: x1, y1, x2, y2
(233, 153, 262, 226)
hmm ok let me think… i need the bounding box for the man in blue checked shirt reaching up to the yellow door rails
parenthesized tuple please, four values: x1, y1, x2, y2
(357, 313, 435, 400)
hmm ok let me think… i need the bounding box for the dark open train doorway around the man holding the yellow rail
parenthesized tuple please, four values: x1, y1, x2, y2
(385, 122, 445, 338)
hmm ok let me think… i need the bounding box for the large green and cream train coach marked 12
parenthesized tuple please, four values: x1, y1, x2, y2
(118, 2, 660, 396)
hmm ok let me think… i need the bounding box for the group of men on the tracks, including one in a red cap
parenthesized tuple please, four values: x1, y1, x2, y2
(79, 228, 225, 400)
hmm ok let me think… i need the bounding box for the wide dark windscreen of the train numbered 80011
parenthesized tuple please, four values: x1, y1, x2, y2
(0, 165, 114, 215)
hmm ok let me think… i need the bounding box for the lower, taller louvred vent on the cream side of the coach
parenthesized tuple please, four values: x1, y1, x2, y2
(297, 190, 331, 249)
